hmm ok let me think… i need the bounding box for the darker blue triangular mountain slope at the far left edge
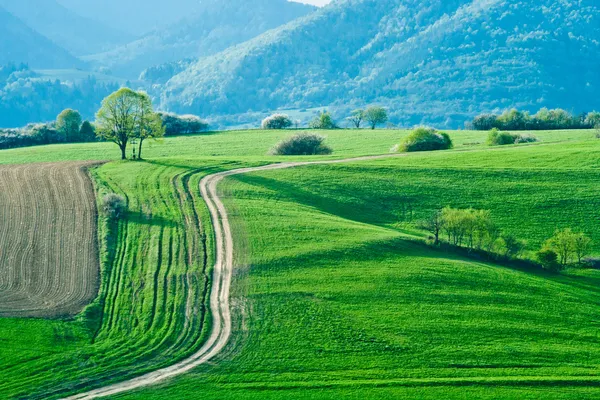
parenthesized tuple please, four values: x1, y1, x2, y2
(0, 7, 83, 69)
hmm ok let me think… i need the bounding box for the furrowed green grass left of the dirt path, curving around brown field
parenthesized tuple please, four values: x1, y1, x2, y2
(0, 160, 245, 399)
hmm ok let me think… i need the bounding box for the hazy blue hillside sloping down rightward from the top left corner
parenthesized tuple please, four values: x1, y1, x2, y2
(0, 0, 132, 55)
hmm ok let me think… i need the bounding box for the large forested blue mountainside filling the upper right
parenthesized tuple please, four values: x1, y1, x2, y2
(161, 0, 600, 127)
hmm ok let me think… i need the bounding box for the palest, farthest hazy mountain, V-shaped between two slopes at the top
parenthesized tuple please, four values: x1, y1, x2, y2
(56, 0, 227, 37)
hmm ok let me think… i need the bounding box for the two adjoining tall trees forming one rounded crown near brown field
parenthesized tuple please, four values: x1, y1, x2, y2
(96, 88, 164, 160)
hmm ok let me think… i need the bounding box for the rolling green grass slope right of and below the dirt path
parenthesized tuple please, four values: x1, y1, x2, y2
(116, 137, 600, 399)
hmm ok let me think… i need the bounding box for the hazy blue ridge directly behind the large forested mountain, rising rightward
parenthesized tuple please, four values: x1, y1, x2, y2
(85, 0, 315, 78)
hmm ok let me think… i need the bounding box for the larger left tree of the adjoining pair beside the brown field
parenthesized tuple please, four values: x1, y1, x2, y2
(96, 88, 139, 160)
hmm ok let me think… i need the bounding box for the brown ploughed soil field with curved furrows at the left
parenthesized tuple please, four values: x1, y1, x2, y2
(0, 162, 100, 318)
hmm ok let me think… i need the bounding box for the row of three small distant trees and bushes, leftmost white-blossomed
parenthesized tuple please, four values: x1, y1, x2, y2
(261, 107, 388, 129)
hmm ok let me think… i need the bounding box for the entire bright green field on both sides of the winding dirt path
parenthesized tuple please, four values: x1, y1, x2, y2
(0, 130, 600, 399)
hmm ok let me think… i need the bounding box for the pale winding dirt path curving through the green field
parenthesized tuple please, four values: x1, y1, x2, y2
(64, 154, 402, 400)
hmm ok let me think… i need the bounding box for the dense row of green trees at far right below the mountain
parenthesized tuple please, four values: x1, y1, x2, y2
(467, 108, 600, 131)
